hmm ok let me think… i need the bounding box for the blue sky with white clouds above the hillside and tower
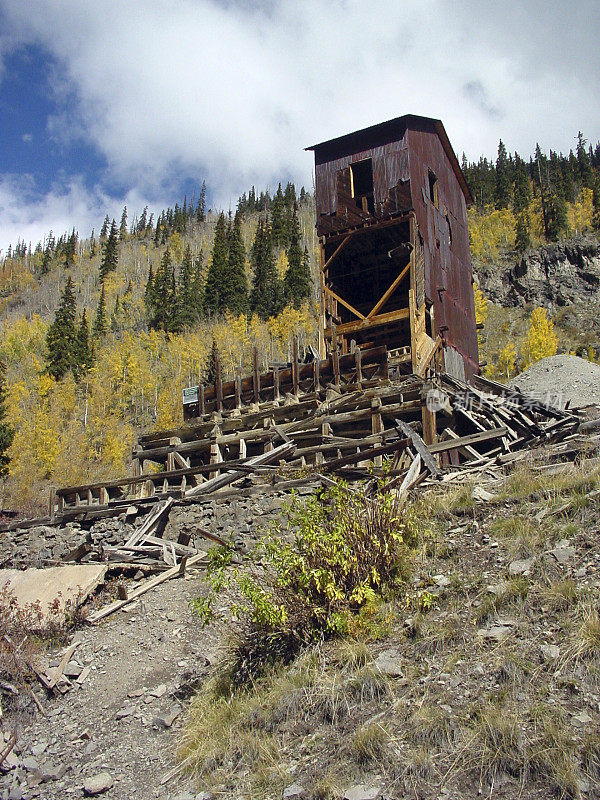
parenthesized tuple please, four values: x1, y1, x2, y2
(0, 0, 600, 255)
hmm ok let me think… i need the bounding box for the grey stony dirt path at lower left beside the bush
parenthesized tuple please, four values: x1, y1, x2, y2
(0, 572, 216, 800)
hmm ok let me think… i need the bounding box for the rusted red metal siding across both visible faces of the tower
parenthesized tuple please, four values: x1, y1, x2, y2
(311, 115, 478, 377)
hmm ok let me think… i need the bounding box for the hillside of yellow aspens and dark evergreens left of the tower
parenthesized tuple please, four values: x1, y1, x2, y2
(0, 184, 317, 511)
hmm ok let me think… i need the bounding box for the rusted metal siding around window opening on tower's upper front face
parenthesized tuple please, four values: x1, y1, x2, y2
(315, 138, 408, 220)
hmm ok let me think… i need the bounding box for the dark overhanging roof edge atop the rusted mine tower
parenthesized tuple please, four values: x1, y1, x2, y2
(305, 114, 473, 203)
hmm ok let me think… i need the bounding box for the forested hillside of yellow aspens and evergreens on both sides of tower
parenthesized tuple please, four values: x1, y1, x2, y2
(0, 134, 600, 512)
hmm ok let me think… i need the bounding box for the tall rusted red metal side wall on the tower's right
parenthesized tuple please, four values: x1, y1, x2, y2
(407, 124, 479, 377)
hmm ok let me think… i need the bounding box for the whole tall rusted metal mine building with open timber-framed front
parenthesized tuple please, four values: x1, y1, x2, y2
(307, 114, 479, 379)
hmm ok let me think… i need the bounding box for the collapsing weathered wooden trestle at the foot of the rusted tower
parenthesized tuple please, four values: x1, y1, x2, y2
(50, 347, 579, 521)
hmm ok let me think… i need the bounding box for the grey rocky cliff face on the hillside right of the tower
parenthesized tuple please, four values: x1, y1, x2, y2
(474, 237, 600, 311)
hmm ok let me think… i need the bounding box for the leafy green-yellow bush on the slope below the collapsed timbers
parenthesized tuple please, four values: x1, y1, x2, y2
(193, 482, 417, 680)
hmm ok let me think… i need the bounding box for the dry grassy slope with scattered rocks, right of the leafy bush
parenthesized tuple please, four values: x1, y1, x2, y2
(182, 466, 600, 800)
